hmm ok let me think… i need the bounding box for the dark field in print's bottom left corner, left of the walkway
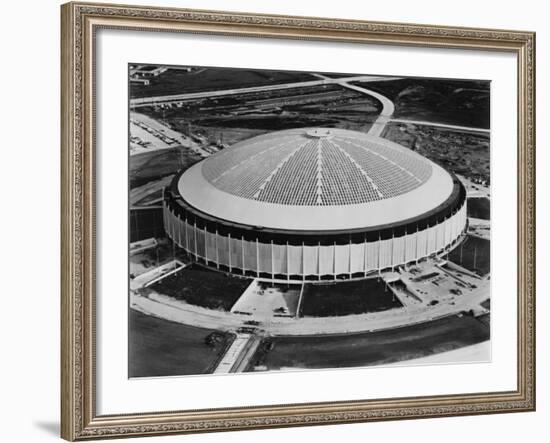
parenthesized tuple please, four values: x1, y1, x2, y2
(128, 309, 231, 377)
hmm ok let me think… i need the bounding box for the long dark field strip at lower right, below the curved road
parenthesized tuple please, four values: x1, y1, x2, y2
(249, 316, 490, 370)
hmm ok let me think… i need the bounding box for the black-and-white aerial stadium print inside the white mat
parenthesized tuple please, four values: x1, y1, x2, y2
(128, 63, 491, 378)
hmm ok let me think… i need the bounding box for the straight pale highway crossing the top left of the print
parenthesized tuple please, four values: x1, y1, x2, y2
(130, 75, 402, 109)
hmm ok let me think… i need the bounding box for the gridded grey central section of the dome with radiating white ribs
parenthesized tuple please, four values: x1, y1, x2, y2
(202, 128, 432, 206)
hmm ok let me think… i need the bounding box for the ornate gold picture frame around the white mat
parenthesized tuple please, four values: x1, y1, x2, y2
(61, 3, 535, 441)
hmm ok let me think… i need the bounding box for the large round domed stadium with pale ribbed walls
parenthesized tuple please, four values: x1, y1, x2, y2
(164, 128, 467, 280)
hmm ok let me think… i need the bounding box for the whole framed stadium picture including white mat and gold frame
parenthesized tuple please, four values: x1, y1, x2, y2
(61, 3, 535, 441)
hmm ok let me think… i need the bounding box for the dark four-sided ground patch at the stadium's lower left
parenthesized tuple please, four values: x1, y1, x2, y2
(150, 265, 251, 311)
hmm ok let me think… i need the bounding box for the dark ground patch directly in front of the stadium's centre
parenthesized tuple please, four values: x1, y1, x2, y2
(300, 278, 403, 317)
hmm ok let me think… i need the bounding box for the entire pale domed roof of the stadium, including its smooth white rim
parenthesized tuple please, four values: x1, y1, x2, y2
(178, 128, 453, 230)
